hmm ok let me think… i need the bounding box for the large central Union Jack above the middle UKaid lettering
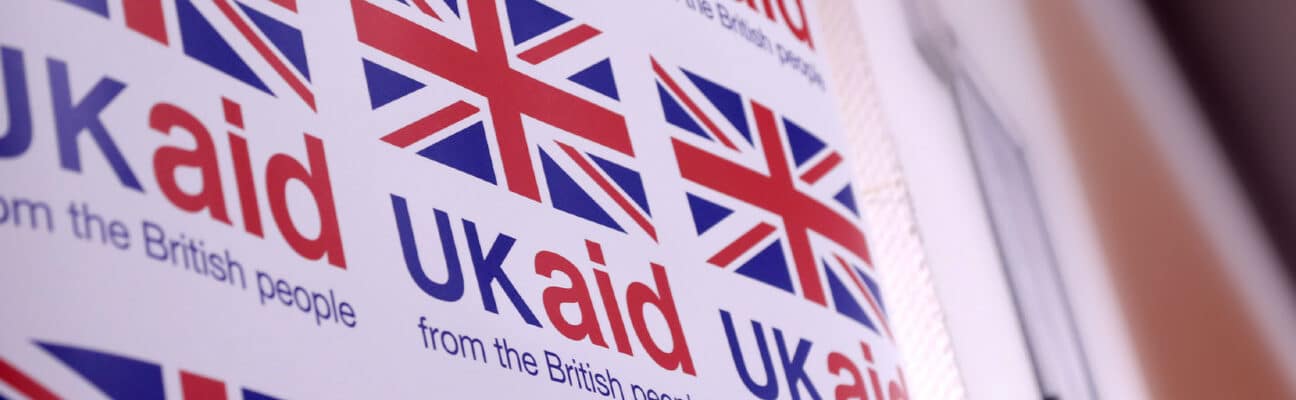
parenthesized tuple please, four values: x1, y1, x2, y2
(351, 0, 657, 239)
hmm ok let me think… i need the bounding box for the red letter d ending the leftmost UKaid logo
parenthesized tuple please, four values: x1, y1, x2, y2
(265, 135, 346, 269)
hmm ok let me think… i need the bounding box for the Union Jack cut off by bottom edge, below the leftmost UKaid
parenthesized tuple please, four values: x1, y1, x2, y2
(0, 342, 277, 400)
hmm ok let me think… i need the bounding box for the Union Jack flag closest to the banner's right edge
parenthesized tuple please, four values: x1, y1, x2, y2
(652, 58, 890, 337)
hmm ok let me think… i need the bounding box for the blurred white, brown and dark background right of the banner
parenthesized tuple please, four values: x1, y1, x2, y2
(826, 0, 1296, 399)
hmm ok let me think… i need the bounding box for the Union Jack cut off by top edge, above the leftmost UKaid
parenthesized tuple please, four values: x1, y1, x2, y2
(55, 0, 315, 110)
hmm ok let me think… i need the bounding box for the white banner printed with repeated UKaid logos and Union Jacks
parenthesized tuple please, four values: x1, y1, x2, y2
(0, 0, 908, 400)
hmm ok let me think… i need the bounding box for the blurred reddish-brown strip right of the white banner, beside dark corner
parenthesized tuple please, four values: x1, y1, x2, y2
(1029, 1, 1296, 399)
